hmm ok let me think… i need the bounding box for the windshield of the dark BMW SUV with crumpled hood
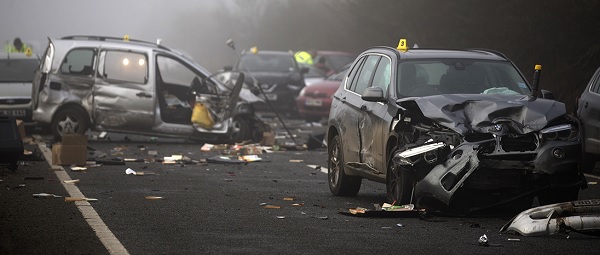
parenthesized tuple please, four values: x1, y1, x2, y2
(396, 59, 530, 96)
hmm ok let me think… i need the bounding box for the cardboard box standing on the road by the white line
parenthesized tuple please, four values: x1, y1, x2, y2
(52, 134, 87, 166)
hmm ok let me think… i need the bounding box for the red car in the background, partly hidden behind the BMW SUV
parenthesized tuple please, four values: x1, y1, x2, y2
(296, 64, 350, 122)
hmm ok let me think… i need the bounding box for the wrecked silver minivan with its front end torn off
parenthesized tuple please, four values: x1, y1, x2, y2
(32, 36, 265, 142)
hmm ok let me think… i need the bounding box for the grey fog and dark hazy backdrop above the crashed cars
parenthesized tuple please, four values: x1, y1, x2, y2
(0, 0, 600, 109)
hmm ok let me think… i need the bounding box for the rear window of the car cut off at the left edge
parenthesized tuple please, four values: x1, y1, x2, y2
(0, 59, 39, 82)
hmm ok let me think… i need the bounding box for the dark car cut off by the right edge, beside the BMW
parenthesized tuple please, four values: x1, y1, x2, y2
(575, 68, 600, 173)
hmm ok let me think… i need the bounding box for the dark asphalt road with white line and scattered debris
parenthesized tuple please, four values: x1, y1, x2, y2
(0, 116, 600, 254)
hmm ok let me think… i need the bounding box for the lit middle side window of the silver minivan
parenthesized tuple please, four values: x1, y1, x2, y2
(102, 51, 148, 84)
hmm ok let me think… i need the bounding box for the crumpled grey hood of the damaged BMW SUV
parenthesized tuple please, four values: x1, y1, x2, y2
(400, 94, 566, 134)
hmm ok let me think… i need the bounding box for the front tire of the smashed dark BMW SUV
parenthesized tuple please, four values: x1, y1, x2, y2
(385, 150, 412, 205)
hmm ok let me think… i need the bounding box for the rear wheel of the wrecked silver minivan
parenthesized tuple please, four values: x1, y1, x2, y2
(50, 108, 89, 138)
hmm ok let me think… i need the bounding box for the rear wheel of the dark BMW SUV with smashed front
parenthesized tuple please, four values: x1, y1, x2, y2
(327, 135, 362, 197)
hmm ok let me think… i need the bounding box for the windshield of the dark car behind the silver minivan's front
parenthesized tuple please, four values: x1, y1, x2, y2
(241, 54, 296, 72)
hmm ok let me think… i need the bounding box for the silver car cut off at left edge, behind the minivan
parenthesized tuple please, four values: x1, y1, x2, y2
(0, 52, 40, 125)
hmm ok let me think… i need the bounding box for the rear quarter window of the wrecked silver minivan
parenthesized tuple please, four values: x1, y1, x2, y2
(60, 49, 96, 75)
